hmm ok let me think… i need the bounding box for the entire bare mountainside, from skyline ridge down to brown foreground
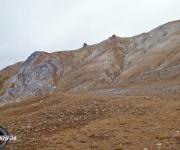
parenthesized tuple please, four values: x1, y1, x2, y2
(0, 21, 180, 150)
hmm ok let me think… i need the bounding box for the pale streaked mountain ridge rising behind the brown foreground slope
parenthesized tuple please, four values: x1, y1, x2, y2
(0, 21, 180, 103)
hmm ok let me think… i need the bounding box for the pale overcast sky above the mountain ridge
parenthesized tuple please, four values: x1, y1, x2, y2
(0, 0, 180, 68)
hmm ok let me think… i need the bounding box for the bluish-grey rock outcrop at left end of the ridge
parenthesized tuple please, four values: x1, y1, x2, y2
(1, 52, 63, 101)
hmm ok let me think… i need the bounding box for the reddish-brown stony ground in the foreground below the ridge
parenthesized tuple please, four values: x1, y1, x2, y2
(0, 93, 180, 150)
